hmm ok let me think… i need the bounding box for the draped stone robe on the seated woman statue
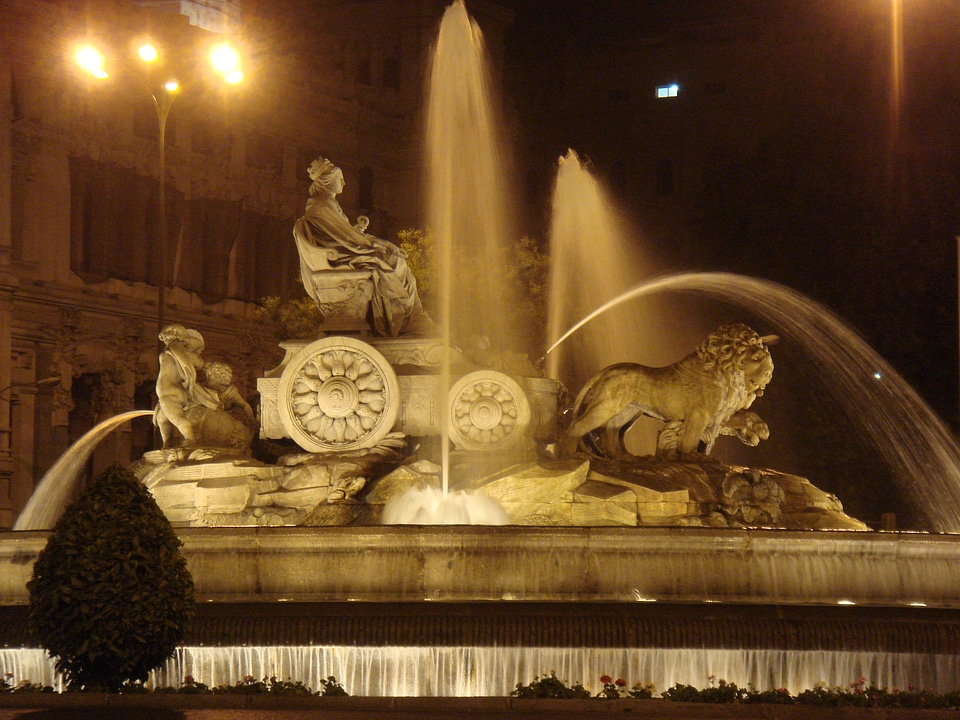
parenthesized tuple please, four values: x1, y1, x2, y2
(293, 194, 424, 337)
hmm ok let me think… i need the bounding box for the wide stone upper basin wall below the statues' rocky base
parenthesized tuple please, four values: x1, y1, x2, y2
(0, 526, 960, 608)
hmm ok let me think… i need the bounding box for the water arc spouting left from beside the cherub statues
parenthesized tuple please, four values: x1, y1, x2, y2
(13, 410, 153, 530)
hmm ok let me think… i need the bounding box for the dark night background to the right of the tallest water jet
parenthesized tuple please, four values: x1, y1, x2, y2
(496, 0, 960, 525)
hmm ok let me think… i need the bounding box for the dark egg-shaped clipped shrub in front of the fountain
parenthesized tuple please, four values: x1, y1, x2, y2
(27, 465, 194, 692)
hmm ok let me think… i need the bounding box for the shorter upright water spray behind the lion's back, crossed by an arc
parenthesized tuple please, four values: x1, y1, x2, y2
(546, 150, 683, 385)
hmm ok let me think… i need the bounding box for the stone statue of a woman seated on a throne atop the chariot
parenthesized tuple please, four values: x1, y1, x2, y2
(293, 158, 434, 337)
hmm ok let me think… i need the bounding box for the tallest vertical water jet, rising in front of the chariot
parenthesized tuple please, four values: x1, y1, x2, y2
(426, 0, 519, 492)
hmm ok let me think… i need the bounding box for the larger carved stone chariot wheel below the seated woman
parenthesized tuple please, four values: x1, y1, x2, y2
(277, 337, 400, 452)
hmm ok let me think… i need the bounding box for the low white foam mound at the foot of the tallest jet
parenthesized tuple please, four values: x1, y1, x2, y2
(381, 488, 510, 525)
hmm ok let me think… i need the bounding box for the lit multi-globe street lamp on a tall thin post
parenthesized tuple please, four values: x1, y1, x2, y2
(74, 37, 243, 344)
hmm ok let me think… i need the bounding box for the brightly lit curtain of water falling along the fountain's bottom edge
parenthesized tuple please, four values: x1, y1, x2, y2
(0, 645, 960, 697)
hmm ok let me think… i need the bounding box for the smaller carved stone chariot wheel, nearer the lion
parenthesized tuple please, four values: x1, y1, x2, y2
(448, 370, 530, 450)
